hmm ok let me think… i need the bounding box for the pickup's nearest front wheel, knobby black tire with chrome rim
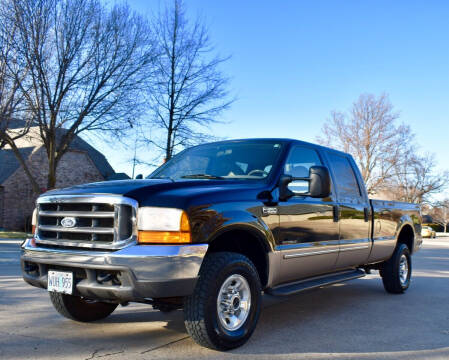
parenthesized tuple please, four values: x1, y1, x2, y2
(184, 252, 261, 350)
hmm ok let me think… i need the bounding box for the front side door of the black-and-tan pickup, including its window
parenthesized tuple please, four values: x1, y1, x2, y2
(277, 145, 339, 282)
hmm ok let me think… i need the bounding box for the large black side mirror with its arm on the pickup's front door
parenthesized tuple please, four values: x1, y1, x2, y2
(279, 166, 331, 201)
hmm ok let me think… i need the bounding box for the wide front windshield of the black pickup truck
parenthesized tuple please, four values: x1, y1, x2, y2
(147, 141, 282, 180)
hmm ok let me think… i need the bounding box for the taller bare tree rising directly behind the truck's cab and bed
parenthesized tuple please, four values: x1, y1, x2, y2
(317, 94, 414, 194)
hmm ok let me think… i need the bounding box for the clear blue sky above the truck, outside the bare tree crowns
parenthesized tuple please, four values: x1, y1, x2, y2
(93, 0, 449, 174)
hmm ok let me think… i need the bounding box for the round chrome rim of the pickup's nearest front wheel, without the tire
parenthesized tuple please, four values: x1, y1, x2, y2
(217, 274, 251, 331)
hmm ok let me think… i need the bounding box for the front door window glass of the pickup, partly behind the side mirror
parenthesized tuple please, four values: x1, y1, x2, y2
(284, 146, 321, 193)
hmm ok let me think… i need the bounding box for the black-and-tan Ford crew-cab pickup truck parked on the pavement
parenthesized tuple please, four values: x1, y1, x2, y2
(21, 139, 422, 350)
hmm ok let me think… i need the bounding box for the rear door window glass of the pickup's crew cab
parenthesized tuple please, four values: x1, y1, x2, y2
(328, 153, 361, 198)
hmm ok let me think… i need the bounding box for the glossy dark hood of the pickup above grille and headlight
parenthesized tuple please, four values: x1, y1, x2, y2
(42, 179, 267, 208)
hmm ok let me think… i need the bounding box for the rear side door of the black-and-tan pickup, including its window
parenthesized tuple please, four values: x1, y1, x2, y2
(327, 151, 372, 269)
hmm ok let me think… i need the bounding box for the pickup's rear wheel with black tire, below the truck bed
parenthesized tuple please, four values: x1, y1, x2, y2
(380, 244, 412, 294)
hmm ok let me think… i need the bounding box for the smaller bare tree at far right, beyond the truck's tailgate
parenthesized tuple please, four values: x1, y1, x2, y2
(389, 154, 449, 204)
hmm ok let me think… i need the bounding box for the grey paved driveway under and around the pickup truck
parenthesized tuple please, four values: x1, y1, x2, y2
(0, 238, 449, 360)
